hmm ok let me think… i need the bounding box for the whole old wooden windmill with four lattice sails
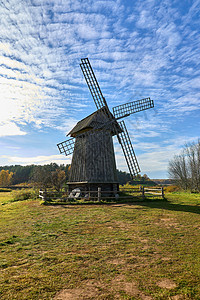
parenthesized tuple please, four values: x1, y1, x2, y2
(57, 58, 154, 193)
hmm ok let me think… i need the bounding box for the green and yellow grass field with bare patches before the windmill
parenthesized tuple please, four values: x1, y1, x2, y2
(0, 192, 200, 300)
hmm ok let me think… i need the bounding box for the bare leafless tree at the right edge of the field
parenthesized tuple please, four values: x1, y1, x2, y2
(168, 140, 200, 192)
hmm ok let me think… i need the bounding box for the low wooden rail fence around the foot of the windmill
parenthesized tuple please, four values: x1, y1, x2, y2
(39, 187, 164, 202)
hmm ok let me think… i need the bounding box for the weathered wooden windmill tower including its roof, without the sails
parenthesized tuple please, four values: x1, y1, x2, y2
(68, 108, 121, 191)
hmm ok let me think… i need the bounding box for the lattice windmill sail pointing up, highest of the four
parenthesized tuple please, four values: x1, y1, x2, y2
(80, 58, 107, 109)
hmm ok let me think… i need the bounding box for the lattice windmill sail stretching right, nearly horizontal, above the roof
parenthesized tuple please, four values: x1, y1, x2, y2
(113, 98, 154, 120)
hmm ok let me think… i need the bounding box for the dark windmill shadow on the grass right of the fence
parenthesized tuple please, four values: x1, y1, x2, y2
(131, 198, 200, 214)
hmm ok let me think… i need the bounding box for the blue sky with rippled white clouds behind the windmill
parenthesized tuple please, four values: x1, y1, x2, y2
(0, 0, 200, 178)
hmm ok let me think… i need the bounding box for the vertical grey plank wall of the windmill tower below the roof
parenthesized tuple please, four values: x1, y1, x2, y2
(69, 130, 118, 183)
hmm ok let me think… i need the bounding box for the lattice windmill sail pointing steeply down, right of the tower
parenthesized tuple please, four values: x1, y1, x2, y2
(118, 121, 140, 177)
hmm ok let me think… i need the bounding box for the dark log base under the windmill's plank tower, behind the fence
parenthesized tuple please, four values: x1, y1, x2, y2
(67, 181, 119, 198)
